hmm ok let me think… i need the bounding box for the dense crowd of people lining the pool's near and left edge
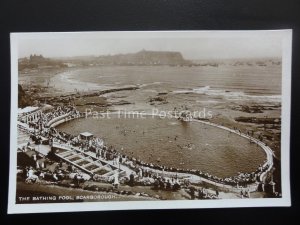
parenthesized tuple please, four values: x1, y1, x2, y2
(18, 106, 268, 195)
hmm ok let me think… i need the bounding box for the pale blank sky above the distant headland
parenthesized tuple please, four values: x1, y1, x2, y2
(17, 31, 282, 60)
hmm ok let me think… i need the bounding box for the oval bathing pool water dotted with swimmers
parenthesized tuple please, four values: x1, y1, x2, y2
(57, 115, 266, 177)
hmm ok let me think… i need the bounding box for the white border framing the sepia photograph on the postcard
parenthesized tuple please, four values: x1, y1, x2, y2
(8, 30, 292, 214)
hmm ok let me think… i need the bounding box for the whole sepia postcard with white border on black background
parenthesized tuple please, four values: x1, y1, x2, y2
(8, 30, 292, 213)
